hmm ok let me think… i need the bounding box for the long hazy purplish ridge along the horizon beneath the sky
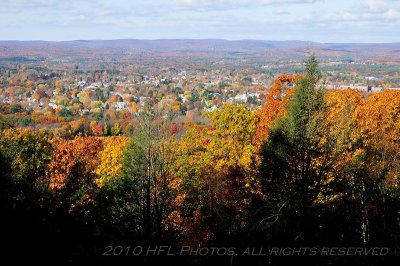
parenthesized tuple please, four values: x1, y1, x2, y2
(0, 39, 400, 60)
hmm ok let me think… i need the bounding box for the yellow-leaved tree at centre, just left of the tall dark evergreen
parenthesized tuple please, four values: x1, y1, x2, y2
(165, 104, 256, 244)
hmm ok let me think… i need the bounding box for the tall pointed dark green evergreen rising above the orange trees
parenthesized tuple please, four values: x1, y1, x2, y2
(260, 55, 331, 244)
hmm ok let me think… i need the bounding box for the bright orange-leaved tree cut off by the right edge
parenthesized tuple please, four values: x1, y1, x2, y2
(354, 90, 400, 190)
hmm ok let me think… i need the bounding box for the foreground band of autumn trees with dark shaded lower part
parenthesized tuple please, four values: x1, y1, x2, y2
(0, 56, 400, 265)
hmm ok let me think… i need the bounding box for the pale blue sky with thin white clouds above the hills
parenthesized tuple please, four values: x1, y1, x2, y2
(0, 0, 400, 43)
